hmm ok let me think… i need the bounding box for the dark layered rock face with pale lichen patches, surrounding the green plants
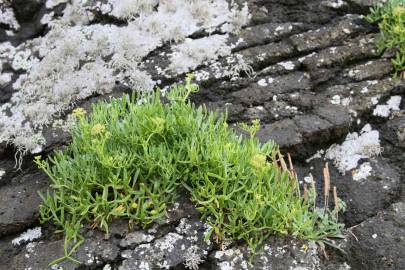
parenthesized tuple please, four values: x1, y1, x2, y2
(0, 0, 405, 270)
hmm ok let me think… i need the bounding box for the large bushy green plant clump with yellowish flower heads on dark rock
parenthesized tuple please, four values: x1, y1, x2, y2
(36, 77, 342, 262)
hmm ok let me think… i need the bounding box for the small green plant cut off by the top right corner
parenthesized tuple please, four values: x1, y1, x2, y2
(366, 0, 405, 76)
